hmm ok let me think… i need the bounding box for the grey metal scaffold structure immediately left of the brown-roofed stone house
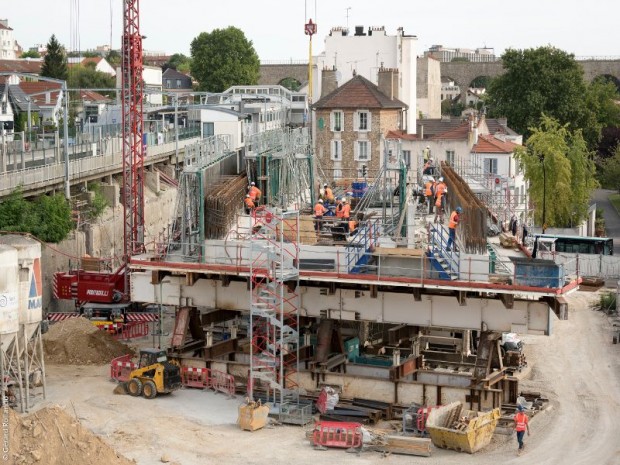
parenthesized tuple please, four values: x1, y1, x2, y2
(245, 128, 314, 208)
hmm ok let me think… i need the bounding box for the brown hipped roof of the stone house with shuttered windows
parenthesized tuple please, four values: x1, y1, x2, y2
(312, 74, 408, 109)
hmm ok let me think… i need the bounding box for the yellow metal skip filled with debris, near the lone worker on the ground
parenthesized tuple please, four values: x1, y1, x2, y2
(426, 402, 500, 454)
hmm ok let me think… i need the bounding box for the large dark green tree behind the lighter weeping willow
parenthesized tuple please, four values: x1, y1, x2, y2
(487, 46, 600, 147)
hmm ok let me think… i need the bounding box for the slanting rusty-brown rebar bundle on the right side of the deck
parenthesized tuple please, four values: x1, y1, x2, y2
(441, 162, 488, 254)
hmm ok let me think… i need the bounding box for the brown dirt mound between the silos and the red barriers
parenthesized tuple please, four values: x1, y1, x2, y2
(43, 318, 133, 365)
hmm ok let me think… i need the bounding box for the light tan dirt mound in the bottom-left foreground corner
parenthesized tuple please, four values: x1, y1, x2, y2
(8, 406, 135, 465)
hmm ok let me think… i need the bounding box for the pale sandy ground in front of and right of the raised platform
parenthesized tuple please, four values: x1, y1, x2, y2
(19, 293, 620, 465)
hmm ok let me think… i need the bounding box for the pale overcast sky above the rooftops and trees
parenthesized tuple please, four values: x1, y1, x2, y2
(0, 0, 620, 60)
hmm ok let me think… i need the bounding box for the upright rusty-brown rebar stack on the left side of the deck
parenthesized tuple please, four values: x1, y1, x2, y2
(204, 175, 248, 239)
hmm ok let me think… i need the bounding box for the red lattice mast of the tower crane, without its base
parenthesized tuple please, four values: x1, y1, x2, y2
(121, 0, 145, 264)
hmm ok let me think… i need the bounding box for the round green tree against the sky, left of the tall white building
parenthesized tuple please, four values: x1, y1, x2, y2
(191, 26, 260, 92)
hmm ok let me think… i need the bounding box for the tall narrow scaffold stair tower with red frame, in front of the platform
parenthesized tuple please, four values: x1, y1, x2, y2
(248, 208, 300, 415)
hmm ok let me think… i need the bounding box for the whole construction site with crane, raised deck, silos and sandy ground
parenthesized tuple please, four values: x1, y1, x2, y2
(0, 0, 620, 465)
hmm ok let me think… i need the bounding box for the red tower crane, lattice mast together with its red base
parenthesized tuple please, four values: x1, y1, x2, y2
(54, 0, 146, 307)
